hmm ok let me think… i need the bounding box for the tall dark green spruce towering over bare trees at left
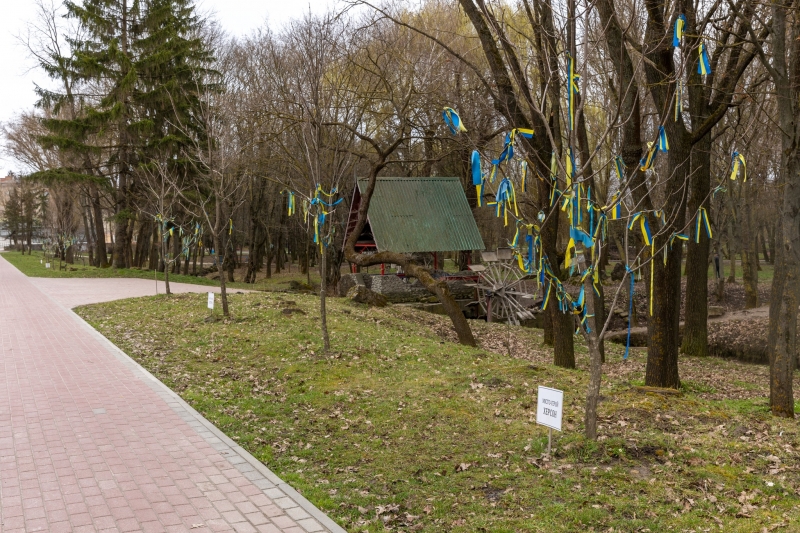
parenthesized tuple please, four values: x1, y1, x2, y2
(34, 0, 211, 268)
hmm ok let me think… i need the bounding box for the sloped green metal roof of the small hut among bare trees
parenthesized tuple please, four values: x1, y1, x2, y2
(358, 177, 484, 253)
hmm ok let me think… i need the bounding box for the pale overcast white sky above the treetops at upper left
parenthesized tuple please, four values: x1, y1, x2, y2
(0, 0, 334, 176)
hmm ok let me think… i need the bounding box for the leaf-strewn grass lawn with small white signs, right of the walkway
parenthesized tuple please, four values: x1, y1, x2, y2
(76, 293, 800, 533)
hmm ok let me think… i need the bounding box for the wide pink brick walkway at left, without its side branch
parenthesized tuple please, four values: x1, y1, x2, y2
(0, 257, 344, 533)
